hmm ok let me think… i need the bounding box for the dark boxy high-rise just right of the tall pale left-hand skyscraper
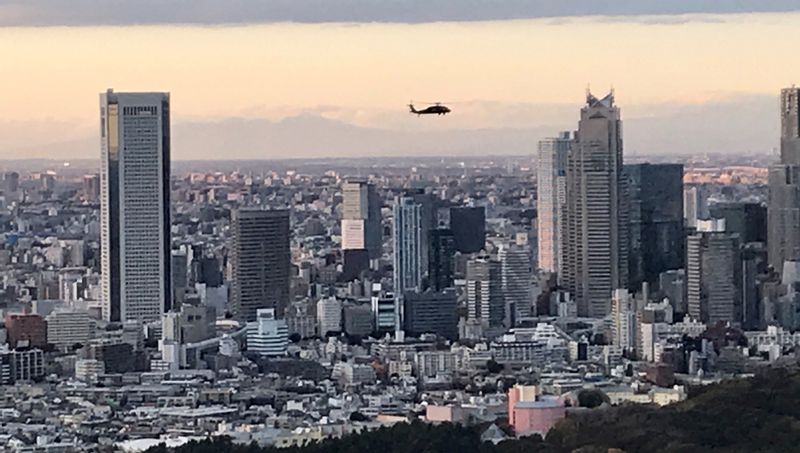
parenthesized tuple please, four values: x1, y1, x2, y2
(230, 209, 290, 322)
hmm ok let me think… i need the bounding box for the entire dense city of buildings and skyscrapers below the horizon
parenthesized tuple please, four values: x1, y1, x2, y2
(0, 84, 800, 452)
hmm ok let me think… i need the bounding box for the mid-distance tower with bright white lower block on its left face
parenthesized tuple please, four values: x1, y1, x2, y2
(342, 179, 382, 259)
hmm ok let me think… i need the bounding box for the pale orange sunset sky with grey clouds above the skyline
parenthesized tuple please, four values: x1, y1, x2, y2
(0, 0, 800, 159)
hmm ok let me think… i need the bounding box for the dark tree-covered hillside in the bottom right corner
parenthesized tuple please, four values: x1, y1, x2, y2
(547, 369, 800, 452)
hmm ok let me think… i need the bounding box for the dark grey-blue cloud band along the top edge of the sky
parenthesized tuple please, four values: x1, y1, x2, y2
(0, 0, 800, 26)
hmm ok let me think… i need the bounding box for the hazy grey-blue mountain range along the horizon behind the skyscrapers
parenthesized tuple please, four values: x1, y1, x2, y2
(0, 95, 779, 160)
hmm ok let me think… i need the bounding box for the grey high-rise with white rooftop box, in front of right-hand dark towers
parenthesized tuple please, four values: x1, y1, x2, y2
(686, 219, 742, 324)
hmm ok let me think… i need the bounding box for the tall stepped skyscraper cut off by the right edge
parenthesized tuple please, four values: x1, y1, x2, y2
(767, 87, 800, 270)
